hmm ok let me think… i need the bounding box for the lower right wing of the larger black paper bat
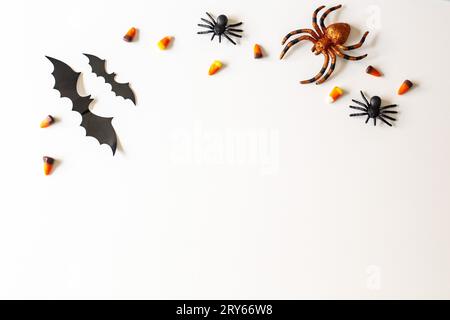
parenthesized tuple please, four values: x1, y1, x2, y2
(80, 112, 117, 155)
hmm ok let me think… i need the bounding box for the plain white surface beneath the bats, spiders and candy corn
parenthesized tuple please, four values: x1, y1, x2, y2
(0, 0, 450, 298)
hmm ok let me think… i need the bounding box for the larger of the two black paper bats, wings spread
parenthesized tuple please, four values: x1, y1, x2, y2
(46, 56, 117, 155)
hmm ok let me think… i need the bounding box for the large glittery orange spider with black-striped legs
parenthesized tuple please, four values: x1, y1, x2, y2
(280, 5, 369, 84)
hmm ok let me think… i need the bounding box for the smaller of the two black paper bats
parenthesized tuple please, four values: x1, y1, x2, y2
(84, 53, 136, 105)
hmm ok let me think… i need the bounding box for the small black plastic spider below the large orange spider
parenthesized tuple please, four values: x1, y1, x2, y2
(350, 91, 397, 127)
